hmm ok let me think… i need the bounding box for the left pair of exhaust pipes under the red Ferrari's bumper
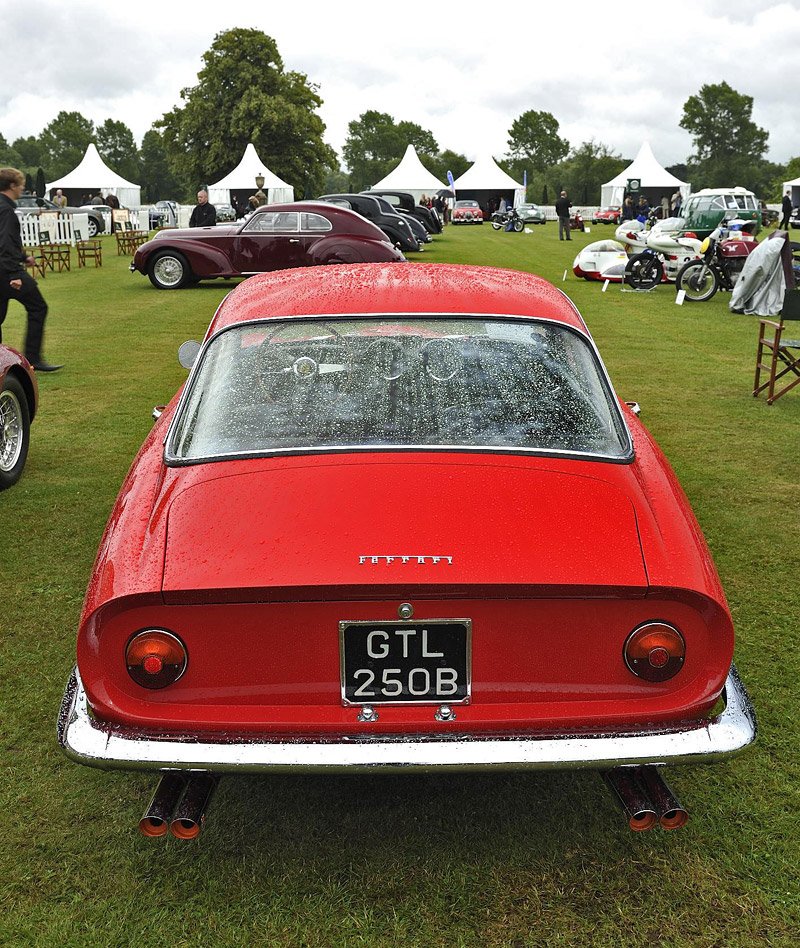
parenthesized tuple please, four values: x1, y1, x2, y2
(139, 770, 216, 839)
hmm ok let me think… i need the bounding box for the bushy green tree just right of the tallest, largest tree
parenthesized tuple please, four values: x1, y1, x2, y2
(342, 109, 438, 191)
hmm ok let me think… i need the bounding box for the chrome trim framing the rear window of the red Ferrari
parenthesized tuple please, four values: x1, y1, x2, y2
(164, 314, 635, 467)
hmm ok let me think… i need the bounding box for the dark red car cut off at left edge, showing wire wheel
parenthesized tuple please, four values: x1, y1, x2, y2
(0, 345, 39, 490)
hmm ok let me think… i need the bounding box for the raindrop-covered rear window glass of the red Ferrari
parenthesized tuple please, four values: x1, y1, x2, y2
(167, 316, 631, 463)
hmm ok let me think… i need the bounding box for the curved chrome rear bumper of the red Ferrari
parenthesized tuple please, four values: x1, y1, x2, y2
(58, 665, 756, 773)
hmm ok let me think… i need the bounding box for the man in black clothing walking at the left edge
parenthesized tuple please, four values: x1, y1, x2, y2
(0, 168, 62, 372)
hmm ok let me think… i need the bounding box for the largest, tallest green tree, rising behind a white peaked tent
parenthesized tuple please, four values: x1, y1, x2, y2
(155, 28, 336, 195)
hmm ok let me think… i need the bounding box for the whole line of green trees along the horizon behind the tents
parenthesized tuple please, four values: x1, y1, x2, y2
(0, 28, 800, 204)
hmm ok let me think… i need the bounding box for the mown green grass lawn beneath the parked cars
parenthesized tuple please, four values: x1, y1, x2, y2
(0, 228, 800, 948)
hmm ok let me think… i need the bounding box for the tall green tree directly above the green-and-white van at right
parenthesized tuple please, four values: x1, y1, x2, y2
(680, 82, 769, 187)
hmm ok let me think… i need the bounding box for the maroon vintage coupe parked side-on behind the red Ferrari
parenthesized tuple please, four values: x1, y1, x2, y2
(131, 201, 405, 290)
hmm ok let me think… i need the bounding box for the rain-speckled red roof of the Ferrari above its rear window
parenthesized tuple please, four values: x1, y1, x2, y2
(208, 263, 588, 335)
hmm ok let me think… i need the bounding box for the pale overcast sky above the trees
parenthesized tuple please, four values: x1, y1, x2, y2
(0, 0, 800, 165)
